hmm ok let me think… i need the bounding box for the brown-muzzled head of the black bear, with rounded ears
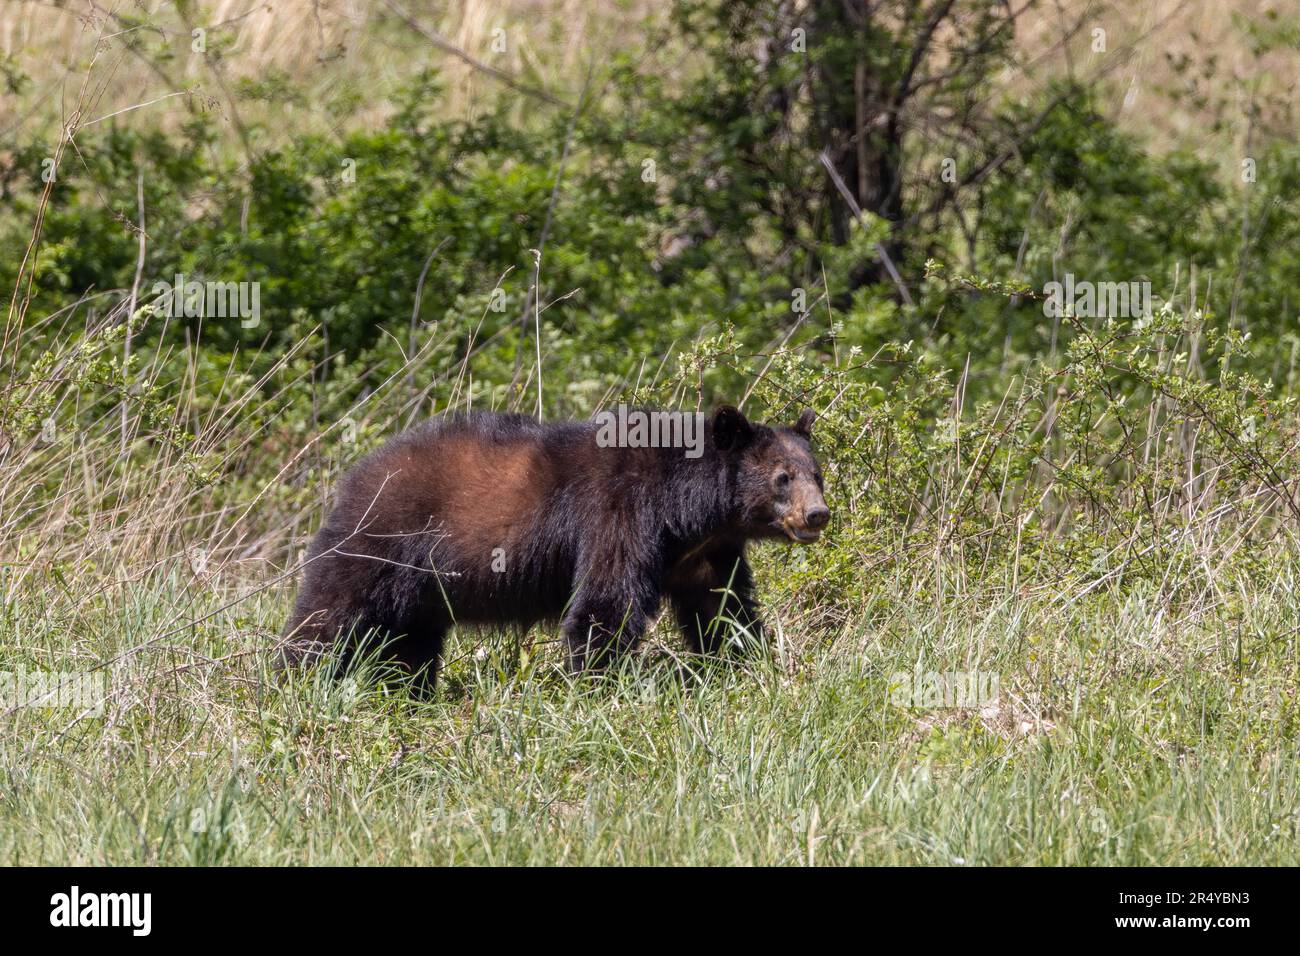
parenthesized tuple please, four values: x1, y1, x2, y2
(712, 405, 831, 544)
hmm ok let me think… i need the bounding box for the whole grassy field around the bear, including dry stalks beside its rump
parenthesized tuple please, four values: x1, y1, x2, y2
(0, 306, 1300, 865)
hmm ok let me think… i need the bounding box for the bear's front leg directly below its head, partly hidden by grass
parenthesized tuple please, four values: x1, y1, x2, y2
(668, 548, 763, 654)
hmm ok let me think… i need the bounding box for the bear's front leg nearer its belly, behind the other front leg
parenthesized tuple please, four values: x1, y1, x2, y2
(563, 566, 659, 674)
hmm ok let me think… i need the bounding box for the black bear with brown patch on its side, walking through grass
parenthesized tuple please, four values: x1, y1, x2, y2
(283, 406, 831, 687)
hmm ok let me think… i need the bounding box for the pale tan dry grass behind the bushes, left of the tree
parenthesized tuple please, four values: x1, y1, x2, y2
(0, 0, 650, 145)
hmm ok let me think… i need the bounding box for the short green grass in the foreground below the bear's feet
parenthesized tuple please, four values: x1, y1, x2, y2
(0, 554, 1300, 865)
